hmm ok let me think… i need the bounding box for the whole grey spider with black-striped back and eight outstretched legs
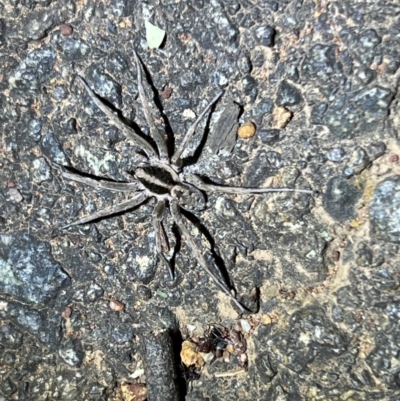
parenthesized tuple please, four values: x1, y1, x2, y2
(61, 51, 313, 313)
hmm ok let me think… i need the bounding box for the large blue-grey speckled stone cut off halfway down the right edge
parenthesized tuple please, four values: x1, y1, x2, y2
(369, 175, 400, 243)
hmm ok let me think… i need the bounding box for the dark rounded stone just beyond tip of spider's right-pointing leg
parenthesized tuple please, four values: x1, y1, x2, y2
(323, 177, 362, 223)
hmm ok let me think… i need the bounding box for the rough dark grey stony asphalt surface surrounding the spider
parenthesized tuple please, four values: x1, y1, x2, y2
(0, 0, 400, 401)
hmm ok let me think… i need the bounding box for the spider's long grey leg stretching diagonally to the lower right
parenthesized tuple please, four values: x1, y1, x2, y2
(170, 200, 248, 313)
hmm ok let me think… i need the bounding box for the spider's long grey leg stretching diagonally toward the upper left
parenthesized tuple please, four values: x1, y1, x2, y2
(78, 75, 157, 157)
